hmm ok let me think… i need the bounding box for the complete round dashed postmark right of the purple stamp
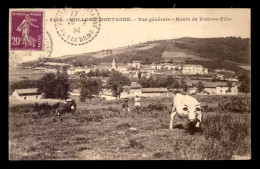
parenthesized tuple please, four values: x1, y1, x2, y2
(54, 9, 100, 46)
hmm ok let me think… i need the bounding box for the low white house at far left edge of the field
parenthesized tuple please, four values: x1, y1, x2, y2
(12, 88, 43, 100)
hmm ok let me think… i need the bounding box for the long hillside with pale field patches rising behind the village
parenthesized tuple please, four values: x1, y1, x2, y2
(19, 37, 251, 69)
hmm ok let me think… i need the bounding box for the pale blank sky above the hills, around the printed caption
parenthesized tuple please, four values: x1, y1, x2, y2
(9, 8, 251, 61)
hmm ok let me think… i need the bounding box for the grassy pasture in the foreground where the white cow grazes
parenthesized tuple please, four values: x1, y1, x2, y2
(9, 96, 251, 160)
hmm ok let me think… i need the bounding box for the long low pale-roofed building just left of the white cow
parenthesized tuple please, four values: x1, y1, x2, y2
(141, 88, 169, 97)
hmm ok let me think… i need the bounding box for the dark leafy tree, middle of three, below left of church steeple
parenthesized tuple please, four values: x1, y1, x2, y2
(79, 78, 102, 102)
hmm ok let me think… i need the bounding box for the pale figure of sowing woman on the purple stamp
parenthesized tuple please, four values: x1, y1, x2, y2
(16, 14, 38, 47)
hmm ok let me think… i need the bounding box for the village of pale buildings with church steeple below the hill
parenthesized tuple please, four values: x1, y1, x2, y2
(12, 58, 239, 100)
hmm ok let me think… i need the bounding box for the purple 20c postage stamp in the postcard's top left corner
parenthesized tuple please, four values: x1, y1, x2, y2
(10, 11, 44, 51)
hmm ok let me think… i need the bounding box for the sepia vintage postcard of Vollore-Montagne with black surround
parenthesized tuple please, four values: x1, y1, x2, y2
(8, 8, 252, 161)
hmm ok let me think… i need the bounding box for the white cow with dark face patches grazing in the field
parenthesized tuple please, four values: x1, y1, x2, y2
(170, 93, 202, 130)
